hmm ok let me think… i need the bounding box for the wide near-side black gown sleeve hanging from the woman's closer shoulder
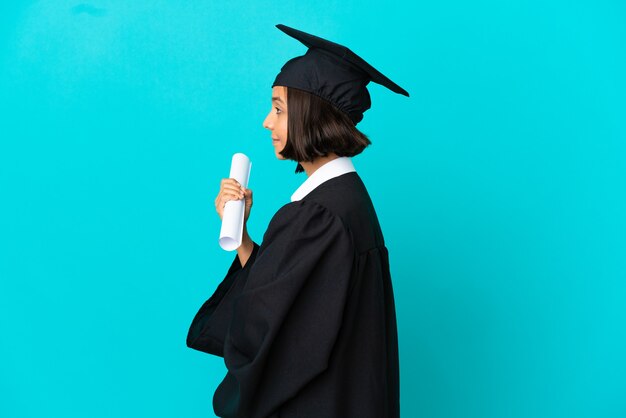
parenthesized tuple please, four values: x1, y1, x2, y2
(213, 200, 354, 418)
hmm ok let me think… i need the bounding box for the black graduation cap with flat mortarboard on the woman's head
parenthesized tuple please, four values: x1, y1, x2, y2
(272, 24, 409, 125)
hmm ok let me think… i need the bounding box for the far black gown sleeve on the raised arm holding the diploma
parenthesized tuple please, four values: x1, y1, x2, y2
(187, 243, 259, 357)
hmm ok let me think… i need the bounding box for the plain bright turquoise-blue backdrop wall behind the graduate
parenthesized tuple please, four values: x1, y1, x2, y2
(0, 0, 626, 418)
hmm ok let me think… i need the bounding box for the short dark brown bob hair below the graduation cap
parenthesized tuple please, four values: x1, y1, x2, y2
(280, 87, 371, 173)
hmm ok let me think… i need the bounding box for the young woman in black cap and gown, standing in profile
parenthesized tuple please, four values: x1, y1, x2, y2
(187, 25, 408, 418)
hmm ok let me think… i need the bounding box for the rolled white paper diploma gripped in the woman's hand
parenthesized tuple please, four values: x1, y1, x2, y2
(220, 152, 252, 251)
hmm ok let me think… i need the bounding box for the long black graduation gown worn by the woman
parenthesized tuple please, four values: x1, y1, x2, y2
(187, 172, 400, 418)
